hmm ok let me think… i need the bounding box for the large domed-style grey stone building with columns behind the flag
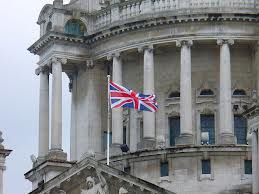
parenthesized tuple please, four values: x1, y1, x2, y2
(25, 0, 259, 194)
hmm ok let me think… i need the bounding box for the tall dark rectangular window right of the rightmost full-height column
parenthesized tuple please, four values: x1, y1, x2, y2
(234, 115, 247, 144)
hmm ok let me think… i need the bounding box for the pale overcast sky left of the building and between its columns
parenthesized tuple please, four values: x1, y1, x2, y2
(0, 0, 70, 194)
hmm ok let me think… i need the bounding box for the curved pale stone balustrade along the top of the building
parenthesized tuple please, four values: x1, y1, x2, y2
(95, 0, 259, 30)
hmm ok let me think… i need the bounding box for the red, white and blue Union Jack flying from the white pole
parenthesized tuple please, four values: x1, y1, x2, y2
(109, 81, 158, 112)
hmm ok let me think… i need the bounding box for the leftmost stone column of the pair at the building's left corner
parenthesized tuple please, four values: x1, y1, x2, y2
(36, 66, 49, 160)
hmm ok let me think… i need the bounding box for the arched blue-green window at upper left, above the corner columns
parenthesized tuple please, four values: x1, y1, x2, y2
(65, 19, 86, 36)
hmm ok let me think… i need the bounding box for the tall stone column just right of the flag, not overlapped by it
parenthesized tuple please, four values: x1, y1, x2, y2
(176, 40, 194, 145)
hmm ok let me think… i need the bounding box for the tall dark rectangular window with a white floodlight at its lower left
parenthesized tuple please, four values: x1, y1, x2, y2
(201, 115, 215, 144)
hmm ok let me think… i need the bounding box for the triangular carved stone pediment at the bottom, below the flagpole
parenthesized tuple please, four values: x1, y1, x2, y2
(30, 158, 176, 194)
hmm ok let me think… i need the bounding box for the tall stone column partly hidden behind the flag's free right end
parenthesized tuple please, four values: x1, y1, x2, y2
(139, 45, 156, 149)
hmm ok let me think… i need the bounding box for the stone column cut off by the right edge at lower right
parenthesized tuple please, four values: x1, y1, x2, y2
(252, 129, 259, 194)
